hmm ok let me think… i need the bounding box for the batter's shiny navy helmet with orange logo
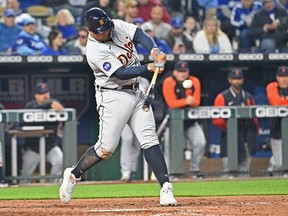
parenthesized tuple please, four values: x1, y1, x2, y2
(85, 7, 113, 34)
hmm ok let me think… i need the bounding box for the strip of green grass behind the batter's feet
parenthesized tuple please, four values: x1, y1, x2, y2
(0, 179, 288, 200)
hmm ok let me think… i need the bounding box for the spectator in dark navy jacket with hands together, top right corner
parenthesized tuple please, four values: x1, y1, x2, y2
(249, 0, 288, 52)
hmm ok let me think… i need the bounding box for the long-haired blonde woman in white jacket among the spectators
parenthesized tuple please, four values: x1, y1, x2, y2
(193, 17, 233, 54)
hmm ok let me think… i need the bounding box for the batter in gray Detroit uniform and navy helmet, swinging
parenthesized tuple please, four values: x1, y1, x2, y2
(59, 8, 177, 205)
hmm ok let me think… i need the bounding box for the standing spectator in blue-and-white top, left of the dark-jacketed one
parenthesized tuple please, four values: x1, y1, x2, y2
(231, 0, 262, 52)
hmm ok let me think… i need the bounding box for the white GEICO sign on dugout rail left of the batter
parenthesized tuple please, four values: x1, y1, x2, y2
(23, 112, 68, 122)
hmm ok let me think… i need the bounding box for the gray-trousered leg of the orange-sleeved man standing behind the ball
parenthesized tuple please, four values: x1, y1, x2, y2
(185, 122, 206, 179)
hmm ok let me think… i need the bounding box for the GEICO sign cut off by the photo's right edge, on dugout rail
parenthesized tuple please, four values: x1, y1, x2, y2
(255, 107, 288, 118)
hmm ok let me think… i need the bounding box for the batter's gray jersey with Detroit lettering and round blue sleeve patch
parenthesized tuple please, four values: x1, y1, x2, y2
(86, 19, 140, 88)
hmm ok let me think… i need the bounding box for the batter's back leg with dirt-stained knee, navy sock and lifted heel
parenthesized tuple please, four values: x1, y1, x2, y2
(59, 90, 136, 203)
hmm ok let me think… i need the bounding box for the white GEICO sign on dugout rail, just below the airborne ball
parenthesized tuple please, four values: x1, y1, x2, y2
(188, 108, 232, 119)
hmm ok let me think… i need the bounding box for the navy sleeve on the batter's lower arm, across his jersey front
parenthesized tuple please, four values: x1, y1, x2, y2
(112, 64, 148, 80)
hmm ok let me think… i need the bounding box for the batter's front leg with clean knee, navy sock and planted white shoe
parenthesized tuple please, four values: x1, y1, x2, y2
(128, 92, 177, 205)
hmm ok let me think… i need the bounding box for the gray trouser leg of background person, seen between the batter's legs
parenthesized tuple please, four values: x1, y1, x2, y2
(120, 125, 134, 181)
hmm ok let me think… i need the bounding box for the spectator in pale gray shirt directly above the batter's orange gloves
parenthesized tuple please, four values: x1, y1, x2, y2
(149, 5, 171, 39)
